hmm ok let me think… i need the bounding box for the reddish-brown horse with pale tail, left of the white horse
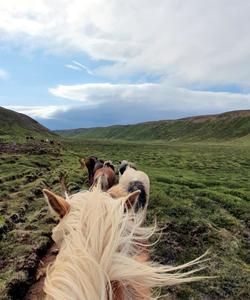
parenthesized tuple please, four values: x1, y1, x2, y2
(91, 161, 116, 191)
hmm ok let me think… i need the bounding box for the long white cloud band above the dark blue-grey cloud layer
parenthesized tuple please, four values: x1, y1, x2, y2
(50, 83, 250, 113)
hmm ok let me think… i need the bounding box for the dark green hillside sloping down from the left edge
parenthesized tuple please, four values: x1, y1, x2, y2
(0, 107, 55, 137)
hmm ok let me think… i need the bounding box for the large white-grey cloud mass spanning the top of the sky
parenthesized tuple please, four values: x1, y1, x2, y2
(0, 0, 250, 87)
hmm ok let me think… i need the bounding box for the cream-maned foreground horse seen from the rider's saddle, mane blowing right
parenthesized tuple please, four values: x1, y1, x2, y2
(43, 185, 206, 300)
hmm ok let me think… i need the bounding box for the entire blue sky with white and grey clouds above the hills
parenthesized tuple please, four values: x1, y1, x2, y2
(0, 0, 250, 129)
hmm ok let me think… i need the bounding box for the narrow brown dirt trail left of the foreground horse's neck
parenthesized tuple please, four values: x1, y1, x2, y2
(24, 244, 58, 300)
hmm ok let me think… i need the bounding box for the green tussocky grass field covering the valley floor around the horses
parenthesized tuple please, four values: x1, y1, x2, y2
(0, 140, 250, 300)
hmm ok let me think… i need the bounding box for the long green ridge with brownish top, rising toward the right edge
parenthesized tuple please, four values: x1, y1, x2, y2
(56, 110, 250, 141)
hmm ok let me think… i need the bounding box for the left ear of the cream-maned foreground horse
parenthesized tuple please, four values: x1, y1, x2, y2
(43, 189, 70, 218)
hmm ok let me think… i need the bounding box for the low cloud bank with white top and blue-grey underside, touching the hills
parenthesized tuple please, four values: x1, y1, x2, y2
(6, 83, 250, 129)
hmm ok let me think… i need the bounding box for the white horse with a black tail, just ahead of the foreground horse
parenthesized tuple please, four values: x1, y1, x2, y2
(108, 165, 150, 212)
